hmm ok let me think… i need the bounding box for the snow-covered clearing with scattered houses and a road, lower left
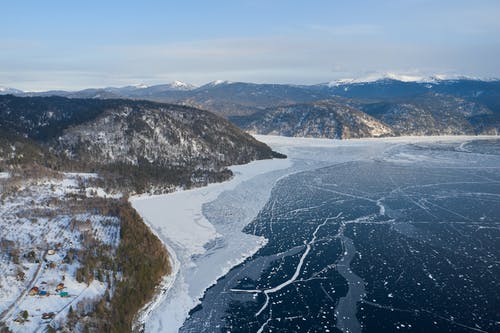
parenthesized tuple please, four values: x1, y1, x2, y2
(0, 174, 120, 332)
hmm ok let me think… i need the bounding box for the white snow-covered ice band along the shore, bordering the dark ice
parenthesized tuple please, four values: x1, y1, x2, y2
(131, 136, 491, 332)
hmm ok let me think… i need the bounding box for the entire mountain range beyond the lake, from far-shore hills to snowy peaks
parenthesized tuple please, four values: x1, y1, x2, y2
(0, 75, 500, 138)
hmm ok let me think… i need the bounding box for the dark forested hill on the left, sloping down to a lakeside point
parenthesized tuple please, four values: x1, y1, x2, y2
(0, 95, 278, 192)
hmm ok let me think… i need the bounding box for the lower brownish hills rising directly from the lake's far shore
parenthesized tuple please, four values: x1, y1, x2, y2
(234, 93, 500, 139)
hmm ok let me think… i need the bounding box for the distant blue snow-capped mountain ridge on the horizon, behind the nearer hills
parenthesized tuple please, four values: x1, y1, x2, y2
(4, 73, 500, 112)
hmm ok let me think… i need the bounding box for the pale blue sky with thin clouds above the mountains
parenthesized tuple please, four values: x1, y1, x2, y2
(0, 0, 500, 91)
